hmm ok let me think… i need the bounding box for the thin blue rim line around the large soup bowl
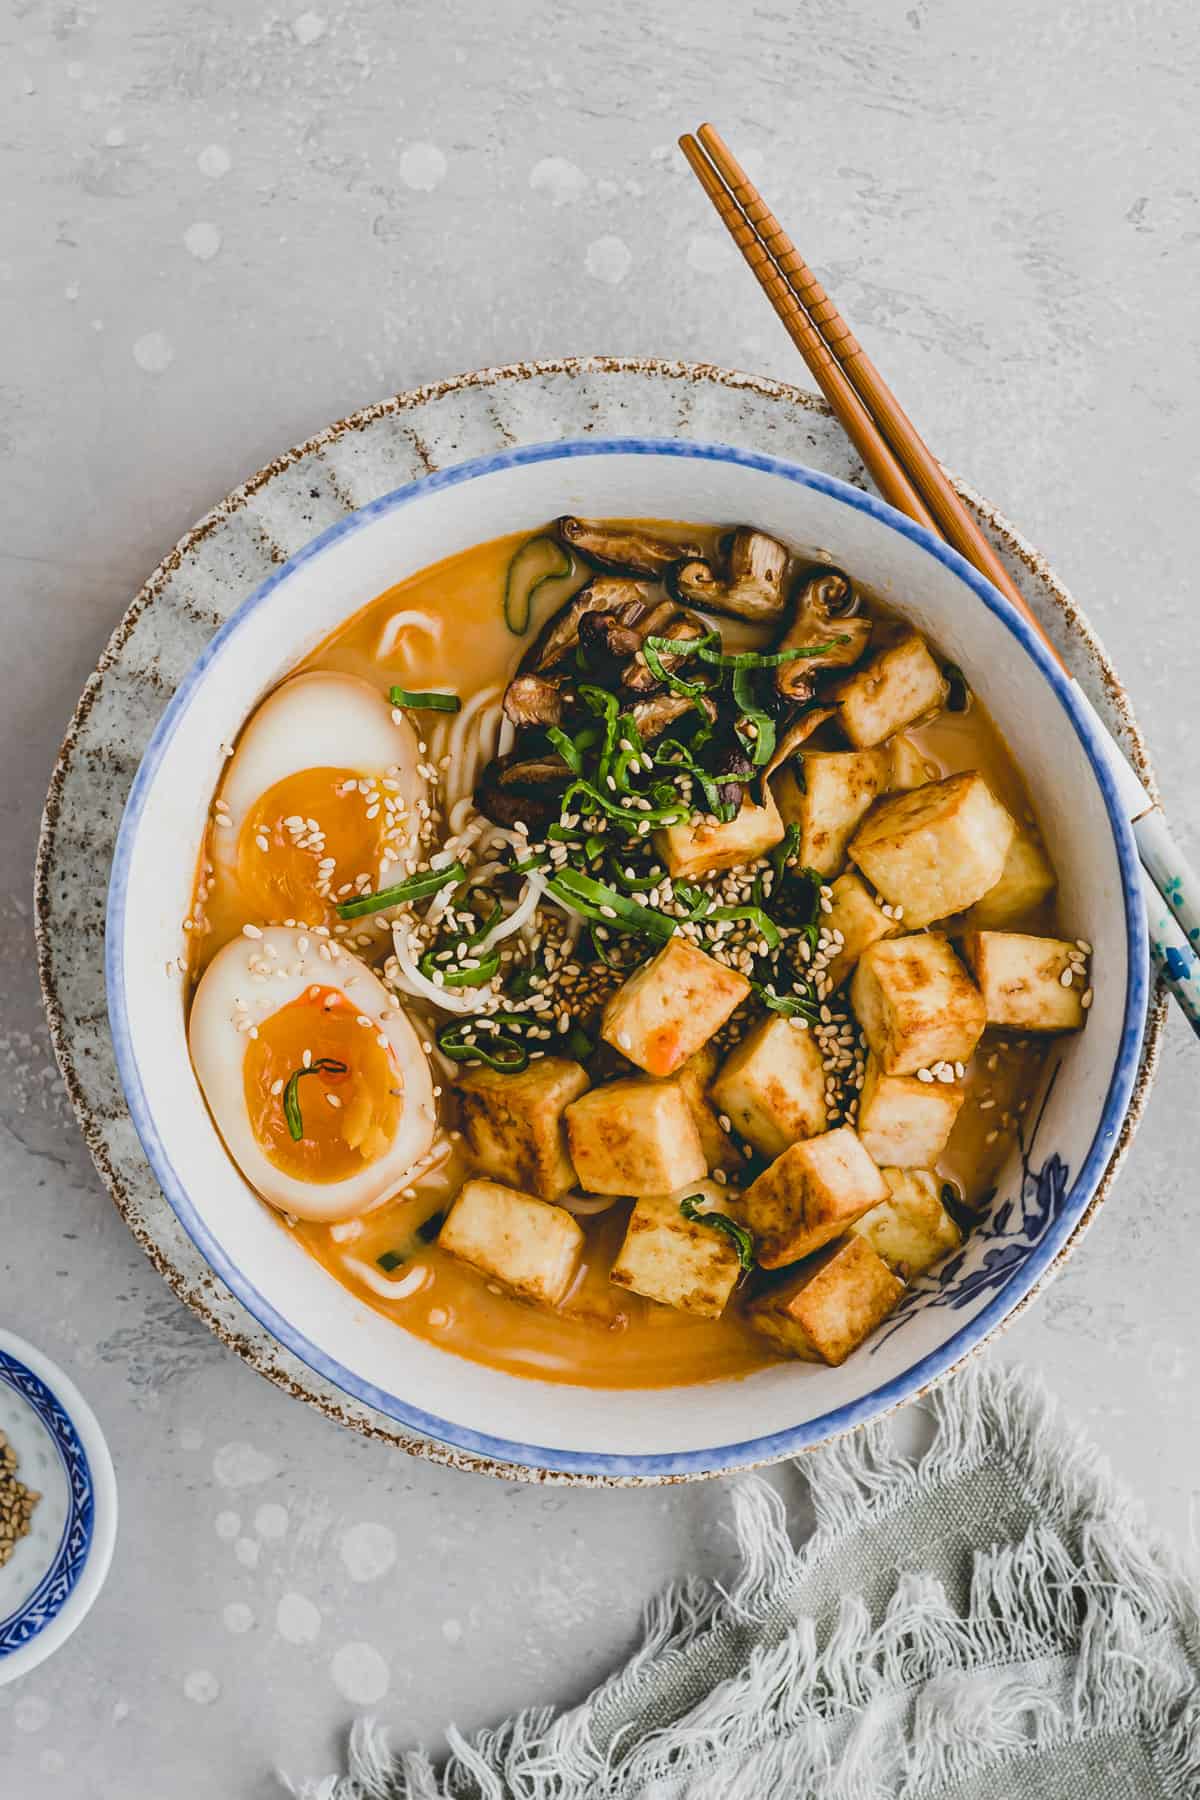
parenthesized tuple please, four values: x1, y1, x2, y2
(104, 436, 1150, 1480)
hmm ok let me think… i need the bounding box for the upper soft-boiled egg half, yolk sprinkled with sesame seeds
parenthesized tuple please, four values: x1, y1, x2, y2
(210, 670, 425, 925)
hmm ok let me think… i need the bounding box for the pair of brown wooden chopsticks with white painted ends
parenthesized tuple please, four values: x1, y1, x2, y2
(680, 124, 1200, 1035)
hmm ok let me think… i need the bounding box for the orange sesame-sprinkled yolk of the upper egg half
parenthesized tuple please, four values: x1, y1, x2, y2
(237, 769, 395, 925)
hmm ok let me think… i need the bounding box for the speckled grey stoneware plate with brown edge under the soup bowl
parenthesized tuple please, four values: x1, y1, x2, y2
(38, 360, 1160, 1483)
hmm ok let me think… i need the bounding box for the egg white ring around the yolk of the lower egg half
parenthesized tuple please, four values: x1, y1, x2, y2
(187, 925, 437, 1222)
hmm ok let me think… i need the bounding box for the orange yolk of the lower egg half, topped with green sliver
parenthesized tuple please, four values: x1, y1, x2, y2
(243, 986, 403, 1183)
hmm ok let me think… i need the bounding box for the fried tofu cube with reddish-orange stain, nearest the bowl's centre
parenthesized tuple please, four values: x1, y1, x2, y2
(601, 936, 750, 1072)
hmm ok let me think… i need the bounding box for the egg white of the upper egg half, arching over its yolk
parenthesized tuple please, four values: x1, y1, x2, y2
(212, 670, 426, 887)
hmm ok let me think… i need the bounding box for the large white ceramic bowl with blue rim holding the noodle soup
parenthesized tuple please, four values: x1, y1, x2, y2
(106, 439, 1148, 1478)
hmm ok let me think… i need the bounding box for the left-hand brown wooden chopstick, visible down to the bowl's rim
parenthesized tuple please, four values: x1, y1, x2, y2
(680, 137, 937, 531)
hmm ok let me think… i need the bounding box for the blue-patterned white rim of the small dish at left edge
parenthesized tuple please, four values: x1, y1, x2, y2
(0, 1328, 117, 1687)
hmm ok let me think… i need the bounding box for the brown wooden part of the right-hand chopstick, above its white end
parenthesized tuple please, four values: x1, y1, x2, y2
(680, 124, 1061, 666)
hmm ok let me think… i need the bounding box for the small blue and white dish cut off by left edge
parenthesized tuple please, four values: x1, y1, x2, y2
(0, 1330, 117, 1685)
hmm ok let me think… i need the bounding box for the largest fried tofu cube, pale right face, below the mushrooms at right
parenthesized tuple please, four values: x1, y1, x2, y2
(849, 769, 1016, 927)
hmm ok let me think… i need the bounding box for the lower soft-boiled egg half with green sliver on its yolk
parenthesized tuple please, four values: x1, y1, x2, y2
(187, 925, 437, 1222)
